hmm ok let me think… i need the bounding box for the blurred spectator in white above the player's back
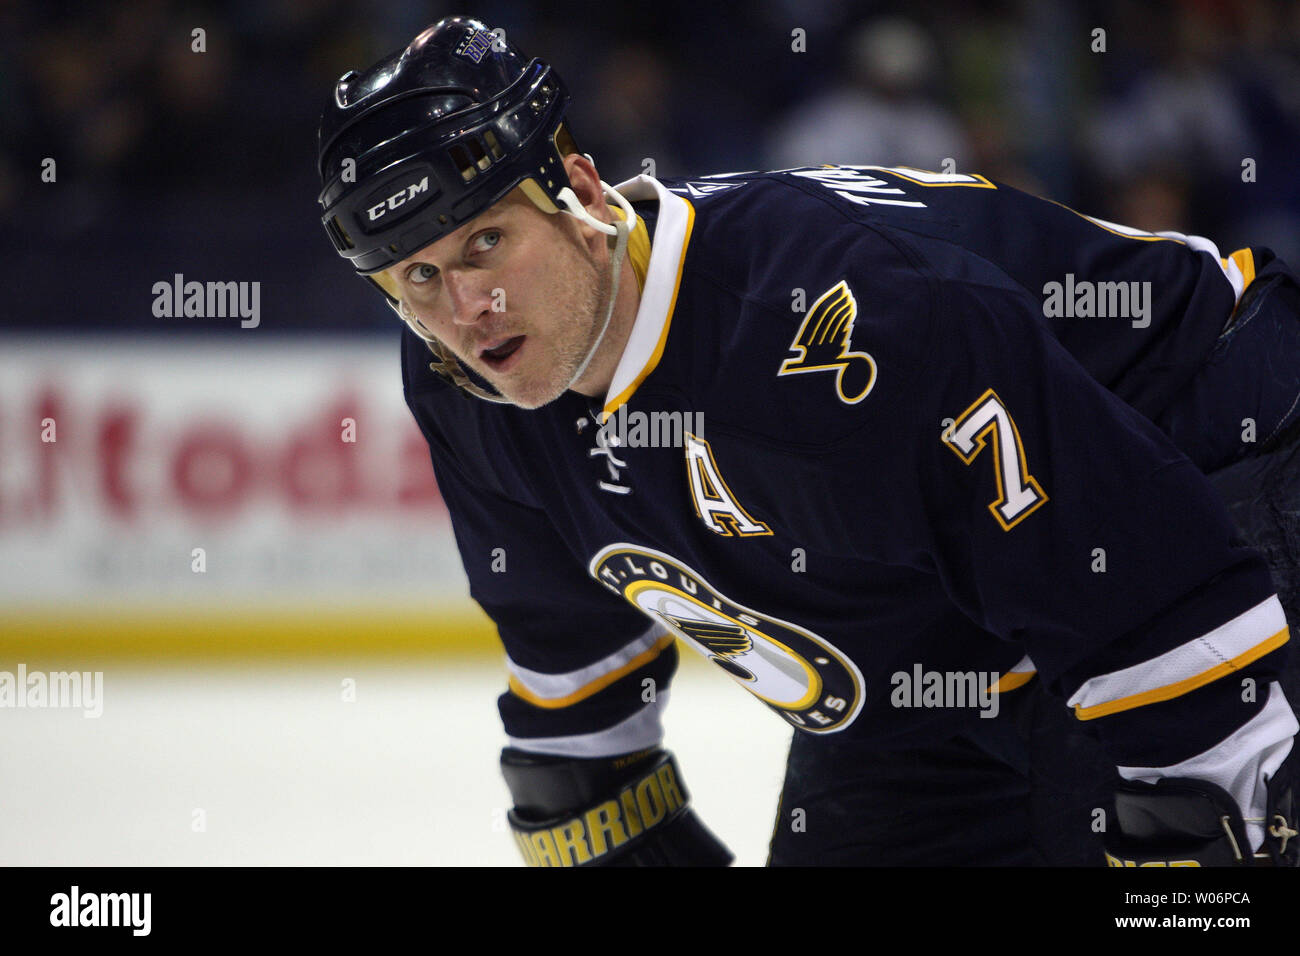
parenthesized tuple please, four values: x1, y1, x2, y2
(767, 18, 967, 169)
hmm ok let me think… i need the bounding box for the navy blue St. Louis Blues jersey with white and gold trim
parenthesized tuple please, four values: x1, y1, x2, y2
(403, 166, 1294, 785)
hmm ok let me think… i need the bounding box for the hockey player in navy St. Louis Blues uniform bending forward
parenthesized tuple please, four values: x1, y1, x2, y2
(320, 17, 1300, 865)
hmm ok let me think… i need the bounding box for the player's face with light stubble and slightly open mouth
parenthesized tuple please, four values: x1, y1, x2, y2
(387, 190, 610, 408)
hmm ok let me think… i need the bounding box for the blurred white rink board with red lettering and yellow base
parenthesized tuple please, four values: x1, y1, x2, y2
(0, 333, 491, 653)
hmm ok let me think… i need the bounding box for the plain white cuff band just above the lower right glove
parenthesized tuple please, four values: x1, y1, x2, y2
(1118, 682, 1300, 849)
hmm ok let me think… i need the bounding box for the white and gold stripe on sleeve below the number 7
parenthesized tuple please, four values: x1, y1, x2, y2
(1067, 594, 1287, 719)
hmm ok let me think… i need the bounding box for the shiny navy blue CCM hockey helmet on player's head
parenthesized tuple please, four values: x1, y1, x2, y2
(317, 17, 569, 299)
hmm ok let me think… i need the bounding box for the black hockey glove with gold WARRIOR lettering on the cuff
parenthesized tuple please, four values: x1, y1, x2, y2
(501, 747, 732, 866)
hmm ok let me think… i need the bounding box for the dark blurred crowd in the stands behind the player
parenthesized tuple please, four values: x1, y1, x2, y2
(0, 0, 1300, 332)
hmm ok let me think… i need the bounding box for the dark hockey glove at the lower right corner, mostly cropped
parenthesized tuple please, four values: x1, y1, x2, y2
(1105, 750, 1300, 866)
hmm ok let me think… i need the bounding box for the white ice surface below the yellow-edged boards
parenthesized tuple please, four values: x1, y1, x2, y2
(0, 657, 790, 866)
